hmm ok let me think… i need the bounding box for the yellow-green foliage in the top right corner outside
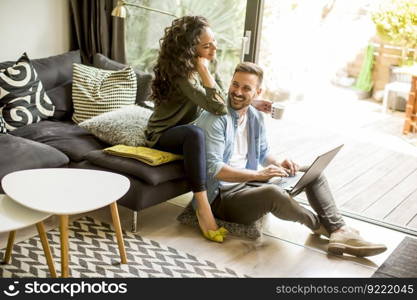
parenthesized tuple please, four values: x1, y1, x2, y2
(372, 0, 417, 48)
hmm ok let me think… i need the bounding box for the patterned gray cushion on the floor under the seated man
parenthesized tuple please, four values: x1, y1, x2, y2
(177, 202, 263, 240)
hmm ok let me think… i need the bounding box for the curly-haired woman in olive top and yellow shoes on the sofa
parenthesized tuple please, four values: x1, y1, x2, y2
(146, 16, 268, 242)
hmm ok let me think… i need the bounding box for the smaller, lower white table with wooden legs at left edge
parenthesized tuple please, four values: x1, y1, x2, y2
(0, 194, 56, 278)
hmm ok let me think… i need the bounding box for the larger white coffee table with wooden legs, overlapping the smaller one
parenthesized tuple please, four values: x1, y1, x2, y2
(1, 168, 130, 277)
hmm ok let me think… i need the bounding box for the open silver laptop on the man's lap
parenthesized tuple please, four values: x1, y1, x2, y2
(247, 144, 343, 196)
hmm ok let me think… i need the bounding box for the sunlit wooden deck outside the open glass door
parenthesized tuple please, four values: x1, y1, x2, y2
(267, 90, 417, 233)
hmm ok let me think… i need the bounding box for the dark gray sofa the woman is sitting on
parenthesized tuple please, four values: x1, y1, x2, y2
(0, 51, 190, 231)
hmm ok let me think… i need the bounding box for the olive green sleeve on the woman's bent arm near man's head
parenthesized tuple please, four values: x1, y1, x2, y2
(177, 78, 227, 115)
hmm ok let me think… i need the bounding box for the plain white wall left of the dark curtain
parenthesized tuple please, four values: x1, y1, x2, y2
(0, 0, 70, 61)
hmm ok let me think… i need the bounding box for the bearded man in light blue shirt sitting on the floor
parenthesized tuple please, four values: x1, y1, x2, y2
(197, 63, 387, 257)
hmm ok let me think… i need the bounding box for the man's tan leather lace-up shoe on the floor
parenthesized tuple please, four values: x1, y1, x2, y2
(328, 231, 387, 257)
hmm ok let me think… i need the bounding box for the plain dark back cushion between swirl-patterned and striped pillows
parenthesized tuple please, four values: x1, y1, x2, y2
(32, 50, 81, 120)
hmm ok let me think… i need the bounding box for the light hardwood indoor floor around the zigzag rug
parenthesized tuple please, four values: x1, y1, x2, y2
(0, 194, 405, 277)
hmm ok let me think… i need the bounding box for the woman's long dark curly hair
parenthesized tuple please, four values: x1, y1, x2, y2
(151, 16, 209, 105)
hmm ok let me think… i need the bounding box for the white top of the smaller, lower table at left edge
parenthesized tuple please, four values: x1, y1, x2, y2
(0, 195, 50, 232)
